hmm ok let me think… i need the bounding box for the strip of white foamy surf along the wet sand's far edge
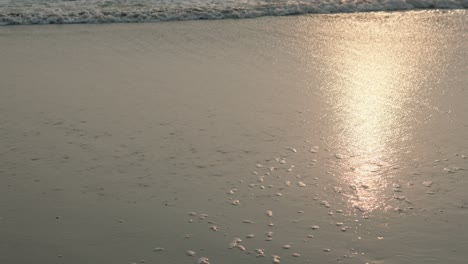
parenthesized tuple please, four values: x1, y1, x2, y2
(0, 0, 468, 25)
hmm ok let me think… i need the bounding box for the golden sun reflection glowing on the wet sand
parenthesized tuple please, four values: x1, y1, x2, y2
(312, 16, 426, 211)
